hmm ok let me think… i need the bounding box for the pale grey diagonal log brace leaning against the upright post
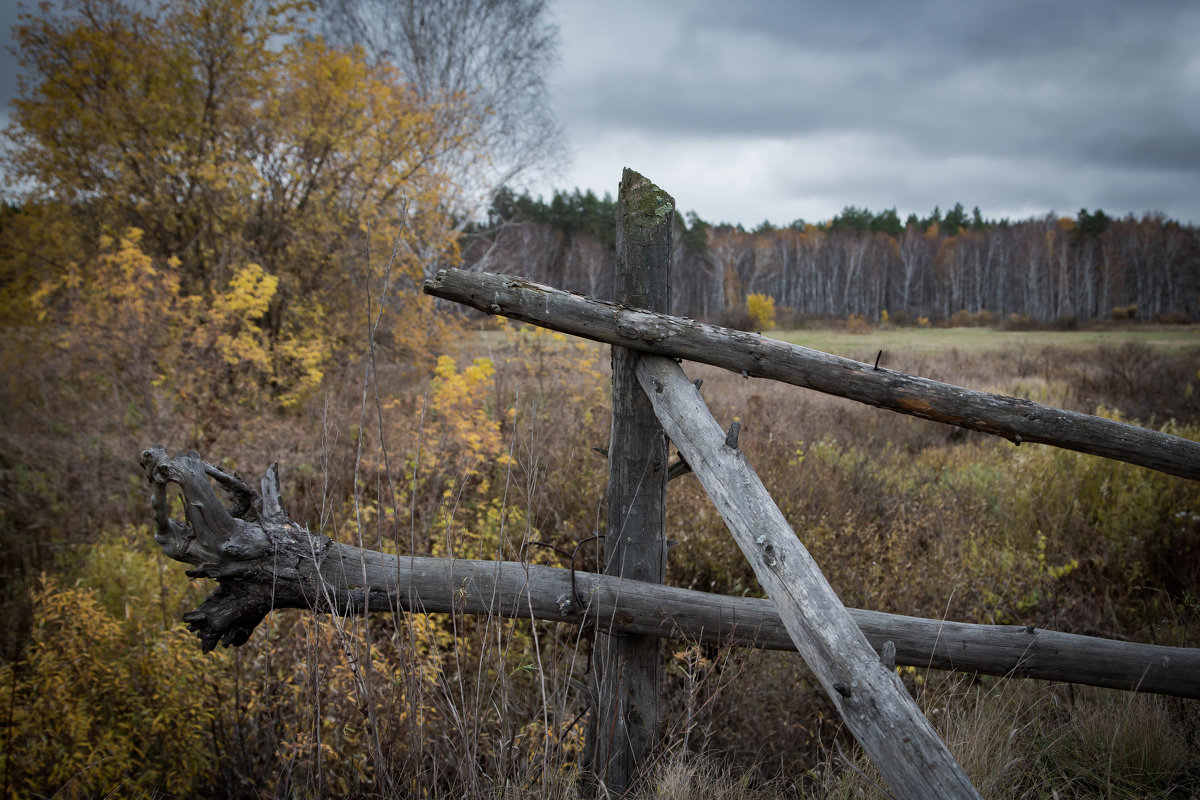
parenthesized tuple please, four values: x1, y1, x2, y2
(637, 355, 979, 800)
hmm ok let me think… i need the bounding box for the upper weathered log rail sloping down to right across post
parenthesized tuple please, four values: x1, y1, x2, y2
(425, 270, 1200, 480)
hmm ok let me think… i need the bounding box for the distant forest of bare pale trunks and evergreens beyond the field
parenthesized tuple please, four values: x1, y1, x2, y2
(463, 190, 1200, 324)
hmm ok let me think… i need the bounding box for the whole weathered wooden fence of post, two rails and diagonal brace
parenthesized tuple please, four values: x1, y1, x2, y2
(143, 170, 1200, 798)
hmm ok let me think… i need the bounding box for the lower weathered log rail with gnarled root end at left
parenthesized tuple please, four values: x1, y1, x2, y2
(143, 447, 1200, 698)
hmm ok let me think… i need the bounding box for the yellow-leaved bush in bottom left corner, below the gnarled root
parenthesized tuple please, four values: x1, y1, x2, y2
(0, 578, 215, 798)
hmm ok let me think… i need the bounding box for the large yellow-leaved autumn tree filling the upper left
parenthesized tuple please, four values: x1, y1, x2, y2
(0, 0, 462, 431)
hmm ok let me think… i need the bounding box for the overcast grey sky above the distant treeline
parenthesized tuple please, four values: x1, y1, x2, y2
(7, 0, 1200, 227)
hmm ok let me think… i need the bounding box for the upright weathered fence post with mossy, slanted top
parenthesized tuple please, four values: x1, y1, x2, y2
(588, 168, 674, 796)
